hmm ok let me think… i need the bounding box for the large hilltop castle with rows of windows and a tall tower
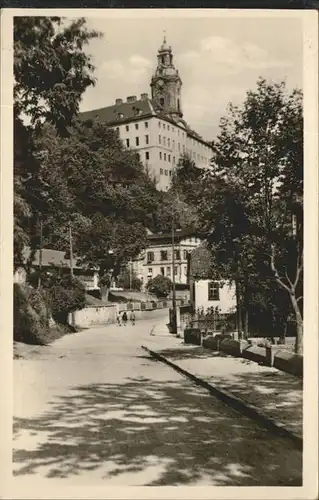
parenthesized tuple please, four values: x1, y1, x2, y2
(80, 37, 212, 190)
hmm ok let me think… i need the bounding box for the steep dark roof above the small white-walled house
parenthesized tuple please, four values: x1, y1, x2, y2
(188, 242, 222, 280)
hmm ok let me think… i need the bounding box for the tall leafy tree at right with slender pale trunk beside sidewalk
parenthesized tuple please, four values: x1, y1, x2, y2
(198, 79, 303, 352)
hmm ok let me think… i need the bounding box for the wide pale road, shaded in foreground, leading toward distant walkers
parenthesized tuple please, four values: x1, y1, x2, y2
(14, 317, 301, 486)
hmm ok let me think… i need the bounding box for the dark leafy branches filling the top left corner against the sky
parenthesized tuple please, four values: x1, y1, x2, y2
(13, 16, 100, 132)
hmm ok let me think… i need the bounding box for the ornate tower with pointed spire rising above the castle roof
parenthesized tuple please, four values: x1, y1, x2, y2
(151, 36, 183, 119)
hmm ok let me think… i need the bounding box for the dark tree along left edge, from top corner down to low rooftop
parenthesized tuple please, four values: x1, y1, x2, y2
(14, 16, 99, 266)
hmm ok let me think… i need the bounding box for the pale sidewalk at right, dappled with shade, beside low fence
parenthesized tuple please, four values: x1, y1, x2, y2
(145, 329, 303, 439)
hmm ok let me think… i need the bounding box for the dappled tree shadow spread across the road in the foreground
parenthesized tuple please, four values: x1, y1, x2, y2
(14, 377, 302, 486)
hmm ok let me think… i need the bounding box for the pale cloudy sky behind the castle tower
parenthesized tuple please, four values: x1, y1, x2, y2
(80, 17, 302, 140)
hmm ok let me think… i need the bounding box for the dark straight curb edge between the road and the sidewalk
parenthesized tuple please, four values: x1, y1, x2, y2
(141, 346, 303, 451)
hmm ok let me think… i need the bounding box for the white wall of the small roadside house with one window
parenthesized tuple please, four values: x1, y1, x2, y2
(195, 280, 236, 314)
